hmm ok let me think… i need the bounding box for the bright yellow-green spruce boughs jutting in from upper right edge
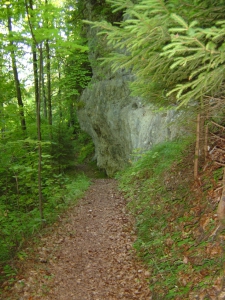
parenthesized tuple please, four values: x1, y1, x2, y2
(162, 14, 225, 105)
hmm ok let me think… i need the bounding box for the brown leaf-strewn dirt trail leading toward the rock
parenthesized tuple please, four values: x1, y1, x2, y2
(2, 179, 151, 300)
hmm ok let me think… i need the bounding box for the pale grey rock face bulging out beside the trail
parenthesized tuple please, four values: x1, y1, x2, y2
(78, 73, 184, 176)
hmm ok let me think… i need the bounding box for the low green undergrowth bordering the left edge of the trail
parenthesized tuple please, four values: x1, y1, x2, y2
(0, 174, 90, 283)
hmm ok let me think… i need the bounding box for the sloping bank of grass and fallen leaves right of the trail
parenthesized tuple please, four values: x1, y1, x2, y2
(118, 140, 225, 299)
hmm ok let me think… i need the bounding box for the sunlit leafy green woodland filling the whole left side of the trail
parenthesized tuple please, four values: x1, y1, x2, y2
(0, 0, 93, 277)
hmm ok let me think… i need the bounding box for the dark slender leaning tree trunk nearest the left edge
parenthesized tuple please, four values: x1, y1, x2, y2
(7, 6, 26, 132)
